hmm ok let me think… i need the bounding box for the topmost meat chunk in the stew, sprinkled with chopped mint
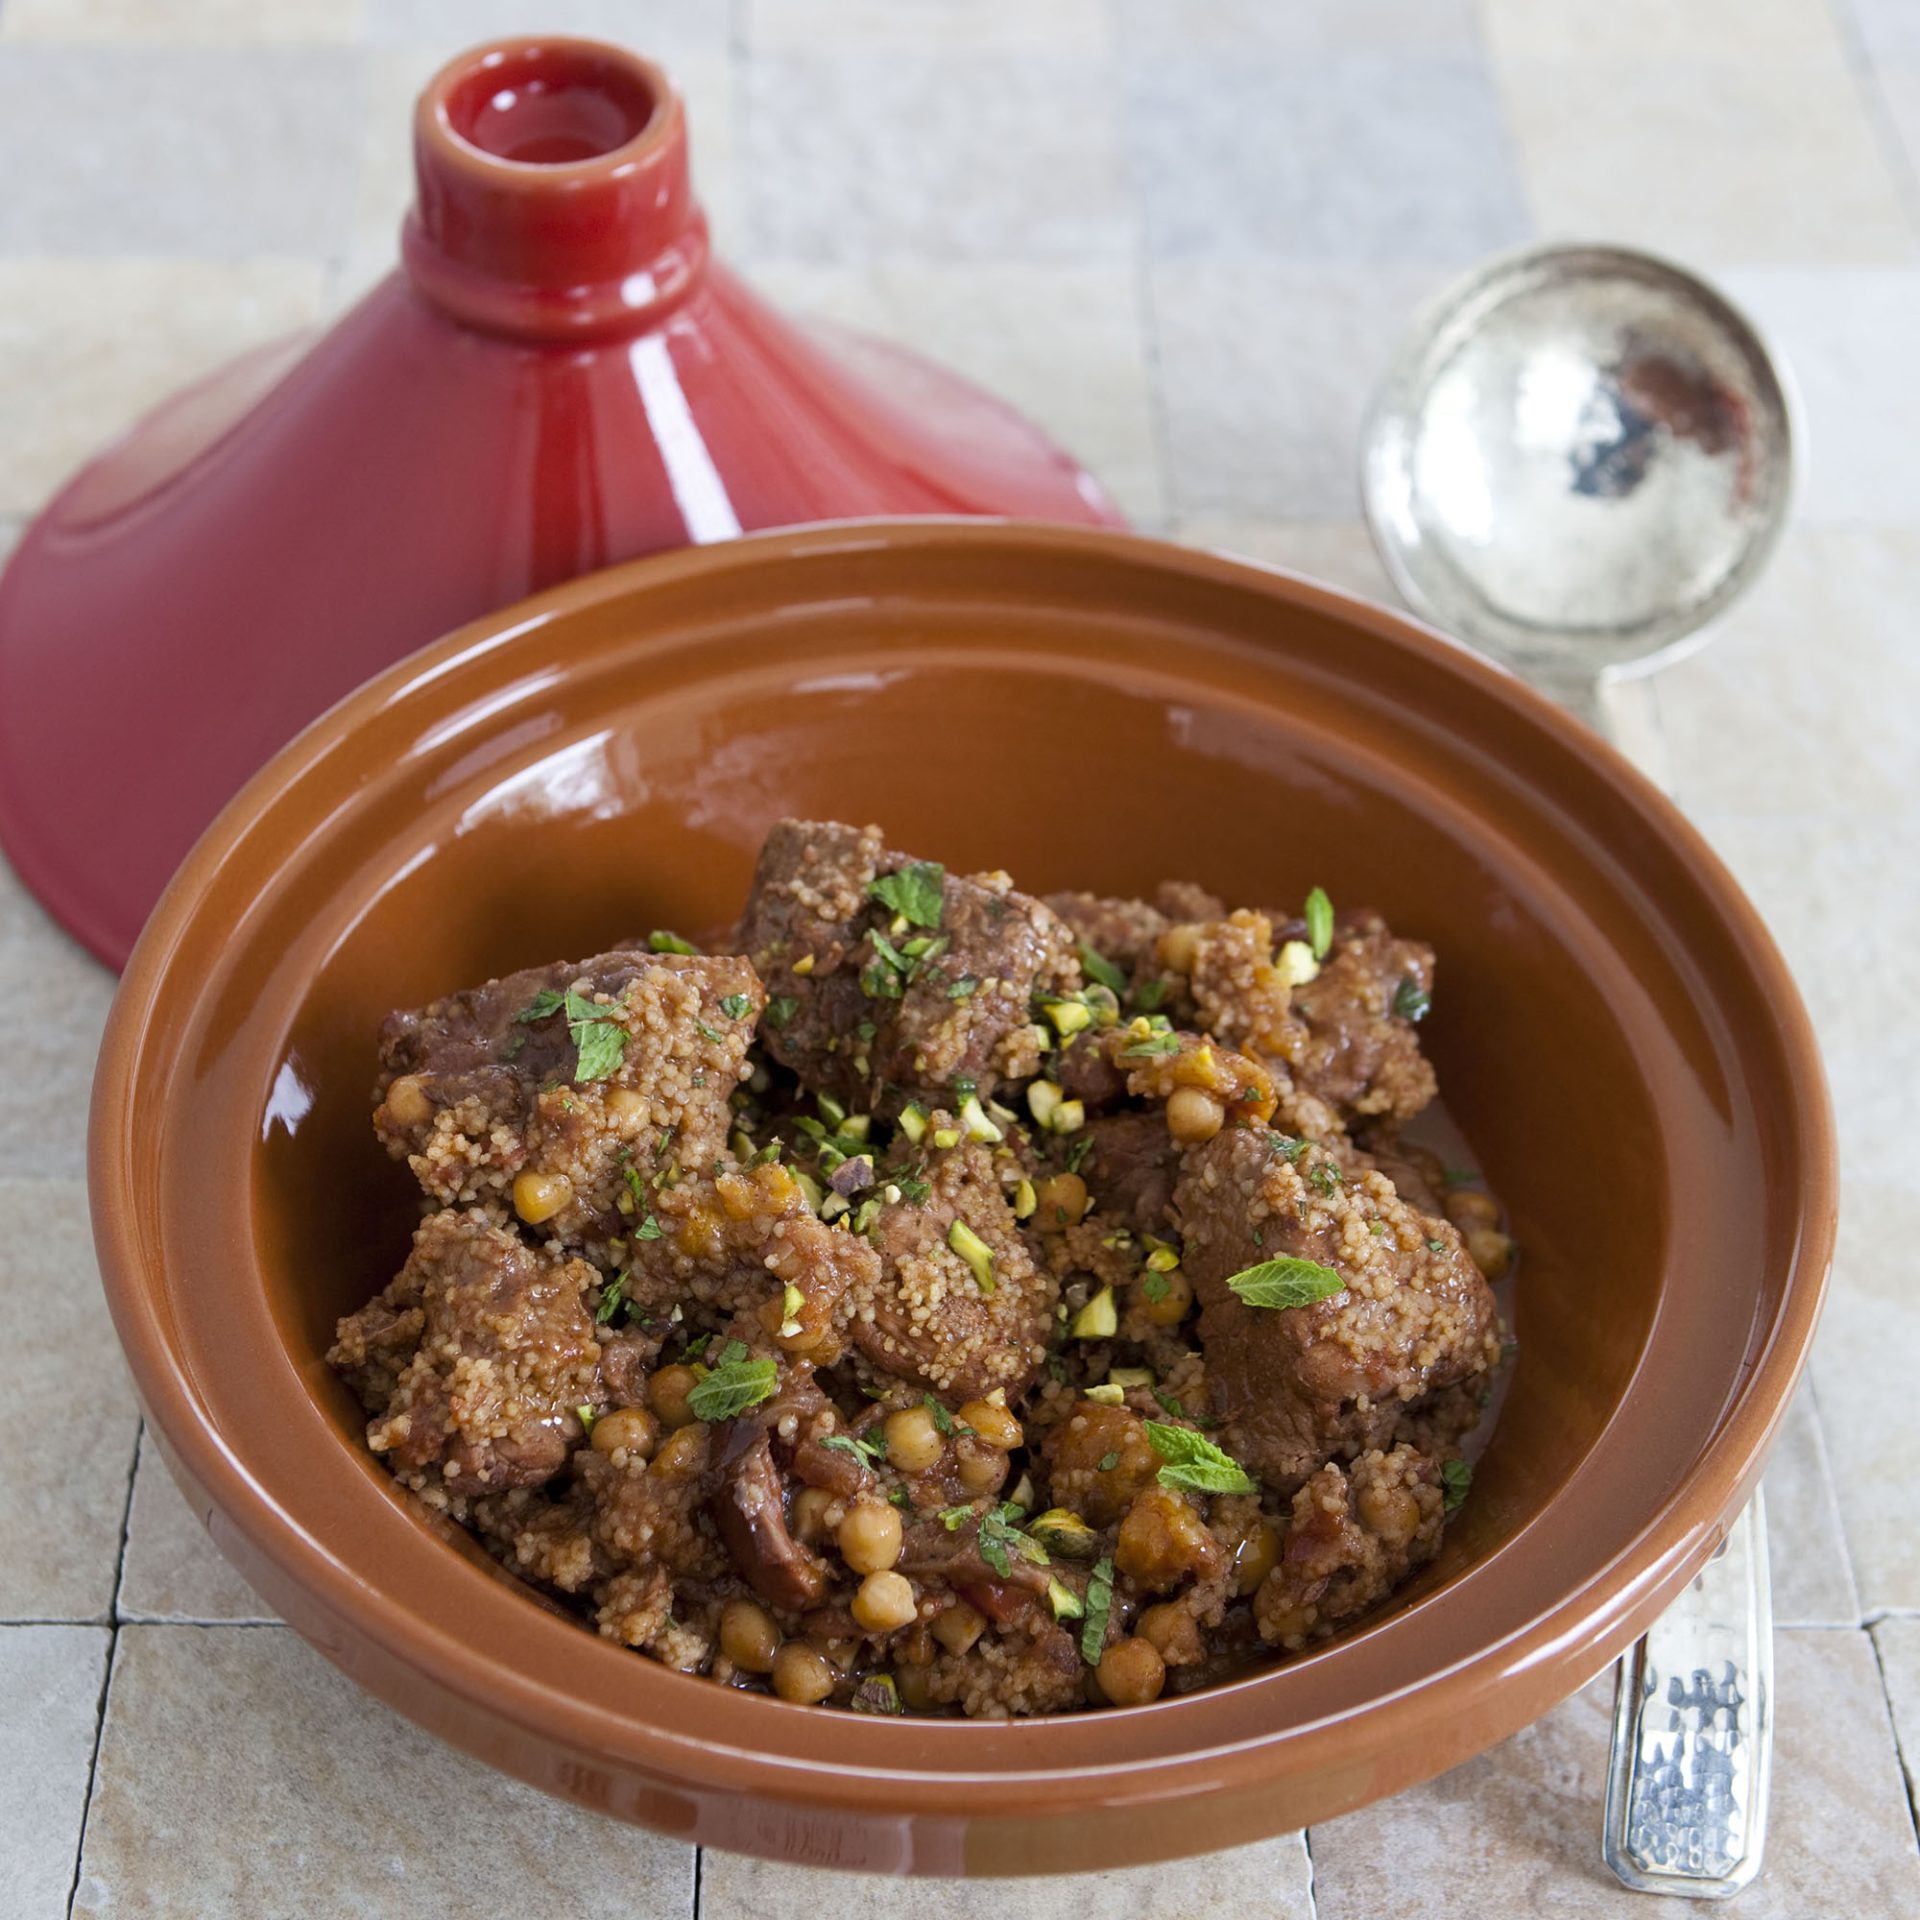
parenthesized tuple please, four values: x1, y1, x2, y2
(739, 820, 1079, 1112)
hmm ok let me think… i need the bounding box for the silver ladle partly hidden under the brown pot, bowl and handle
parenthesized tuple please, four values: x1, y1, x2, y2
(1361, 246, 1799, 1899)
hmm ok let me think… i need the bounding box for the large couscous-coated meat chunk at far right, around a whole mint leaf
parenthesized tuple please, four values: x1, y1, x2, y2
(1173, 1129, 1500, 1492)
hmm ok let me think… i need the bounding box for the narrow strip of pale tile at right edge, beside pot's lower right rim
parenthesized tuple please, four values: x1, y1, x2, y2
(1812, 1179, 1920, 1619)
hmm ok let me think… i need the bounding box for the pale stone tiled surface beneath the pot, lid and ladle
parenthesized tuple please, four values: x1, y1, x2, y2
(0, 0, 1920, 1920)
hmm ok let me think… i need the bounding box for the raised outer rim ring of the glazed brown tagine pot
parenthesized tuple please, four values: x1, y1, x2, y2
(88, 518, 1837, 1851)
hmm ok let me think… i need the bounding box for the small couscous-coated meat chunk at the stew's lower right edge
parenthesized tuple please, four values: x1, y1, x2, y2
(1254, 1446, 1446, 1647)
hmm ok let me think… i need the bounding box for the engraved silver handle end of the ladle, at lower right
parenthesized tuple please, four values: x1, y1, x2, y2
(1601, 1490, 1774, 1901)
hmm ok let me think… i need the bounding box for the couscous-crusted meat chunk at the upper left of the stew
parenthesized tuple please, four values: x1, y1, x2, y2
(374, 952, 762, 1246)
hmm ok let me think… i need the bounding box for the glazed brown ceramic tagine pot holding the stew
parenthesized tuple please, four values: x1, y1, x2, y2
(92, 522, 1836, 1874)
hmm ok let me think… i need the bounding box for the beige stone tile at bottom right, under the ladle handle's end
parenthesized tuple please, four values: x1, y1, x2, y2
(1308, 1630, 1920, 1920)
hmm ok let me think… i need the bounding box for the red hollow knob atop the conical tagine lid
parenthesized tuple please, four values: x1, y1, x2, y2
(401, 36, 707, 340)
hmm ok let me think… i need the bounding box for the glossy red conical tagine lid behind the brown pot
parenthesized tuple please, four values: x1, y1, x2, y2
(0, 36, 1119, 966)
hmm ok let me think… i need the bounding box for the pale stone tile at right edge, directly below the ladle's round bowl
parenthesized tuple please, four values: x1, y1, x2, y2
(1661, 528, 1920, 820)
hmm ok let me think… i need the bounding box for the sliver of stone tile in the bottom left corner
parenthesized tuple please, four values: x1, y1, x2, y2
(0, 1626, 111, 1920)
